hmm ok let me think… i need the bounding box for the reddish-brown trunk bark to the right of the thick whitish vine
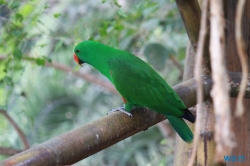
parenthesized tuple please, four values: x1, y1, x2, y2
(224, 0, 250, 166)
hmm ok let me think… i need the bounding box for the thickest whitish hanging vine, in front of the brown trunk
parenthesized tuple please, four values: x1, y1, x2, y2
(210, 0, 234, 162)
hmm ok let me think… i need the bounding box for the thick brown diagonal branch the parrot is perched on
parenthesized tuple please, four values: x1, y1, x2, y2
(0, 73, 250, 166)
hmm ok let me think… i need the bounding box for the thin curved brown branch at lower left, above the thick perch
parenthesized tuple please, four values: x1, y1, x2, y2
(0, 110, 29, 149)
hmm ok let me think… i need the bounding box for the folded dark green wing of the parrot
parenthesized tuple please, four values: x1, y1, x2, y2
(109, 55, 186, 116)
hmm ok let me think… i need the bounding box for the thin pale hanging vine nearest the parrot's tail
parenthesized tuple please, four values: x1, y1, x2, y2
(188, 0, 208, 166)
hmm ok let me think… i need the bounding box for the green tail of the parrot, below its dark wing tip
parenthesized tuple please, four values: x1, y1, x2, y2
(167, 116, 193, 143)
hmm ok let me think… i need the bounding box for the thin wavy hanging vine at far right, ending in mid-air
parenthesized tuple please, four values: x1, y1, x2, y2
(235, 0, 248, 116)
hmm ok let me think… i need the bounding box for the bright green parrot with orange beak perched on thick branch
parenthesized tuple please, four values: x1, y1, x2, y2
(74, 41, 195, 143)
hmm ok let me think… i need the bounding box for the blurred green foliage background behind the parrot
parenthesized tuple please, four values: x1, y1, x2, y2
(0, 0, 188, 166)
